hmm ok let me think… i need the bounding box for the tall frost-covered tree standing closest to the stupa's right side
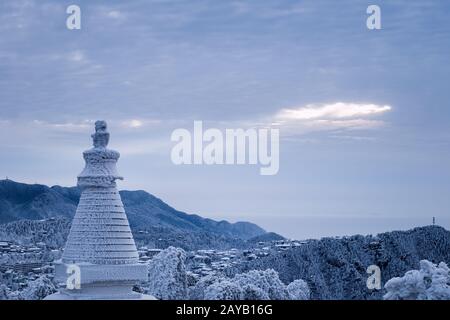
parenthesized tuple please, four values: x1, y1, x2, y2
(146, 247, 187, 300)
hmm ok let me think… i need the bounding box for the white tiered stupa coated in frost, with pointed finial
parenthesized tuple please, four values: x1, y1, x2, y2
(46, 121, 153, 300)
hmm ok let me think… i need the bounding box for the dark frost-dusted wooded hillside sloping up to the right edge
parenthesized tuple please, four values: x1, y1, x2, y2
(227, 226, 450, 300)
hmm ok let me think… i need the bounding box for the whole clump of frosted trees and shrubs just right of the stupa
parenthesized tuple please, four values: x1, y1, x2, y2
(145, 247, 309, 300)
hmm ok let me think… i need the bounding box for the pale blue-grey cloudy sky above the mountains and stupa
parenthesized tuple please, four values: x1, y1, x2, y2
(0, 0, 450, 238)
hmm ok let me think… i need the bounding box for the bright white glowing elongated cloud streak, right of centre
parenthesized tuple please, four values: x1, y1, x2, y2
(276, 102, 391, 121)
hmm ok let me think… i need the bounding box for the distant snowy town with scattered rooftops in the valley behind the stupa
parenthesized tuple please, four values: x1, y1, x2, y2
(0, 229, 307, 291)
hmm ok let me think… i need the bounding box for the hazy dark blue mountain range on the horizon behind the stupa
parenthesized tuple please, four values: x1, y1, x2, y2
(0, 180, 278, 249)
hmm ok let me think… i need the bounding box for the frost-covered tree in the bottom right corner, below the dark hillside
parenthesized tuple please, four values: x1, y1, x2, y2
(383, 260, 450, 300)
